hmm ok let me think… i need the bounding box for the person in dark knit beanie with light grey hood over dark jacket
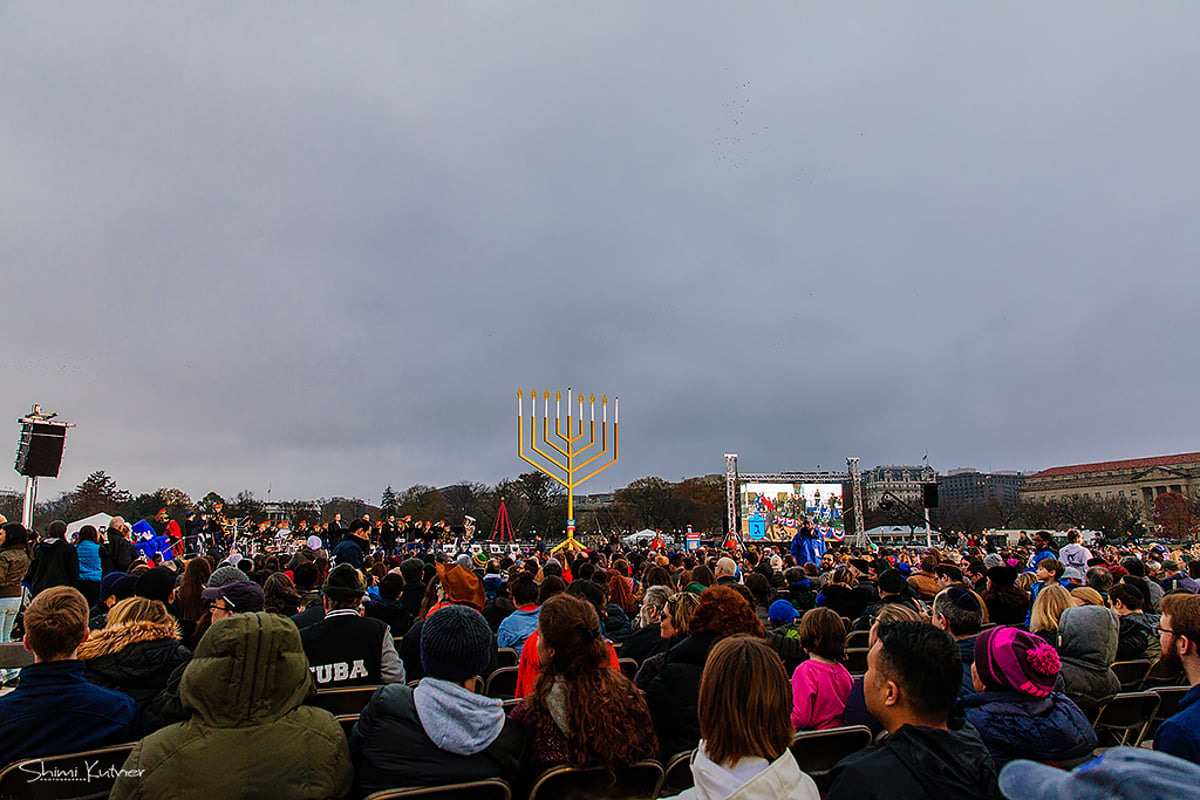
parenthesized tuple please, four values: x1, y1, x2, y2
(350, 606, 524, 796)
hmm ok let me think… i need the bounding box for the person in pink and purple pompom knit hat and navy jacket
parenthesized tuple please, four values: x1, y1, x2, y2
(959, 626, 1097, 769)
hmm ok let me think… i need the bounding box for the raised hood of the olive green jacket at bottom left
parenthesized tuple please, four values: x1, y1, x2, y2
(179, 612, 312, 728)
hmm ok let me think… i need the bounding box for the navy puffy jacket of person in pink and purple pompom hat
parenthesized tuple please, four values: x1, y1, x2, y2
(959, 691, 1097, 771)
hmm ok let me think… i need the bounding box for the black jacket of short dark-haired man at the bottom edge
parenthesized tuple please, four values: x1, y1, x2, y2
(826, 724, 1002, 800)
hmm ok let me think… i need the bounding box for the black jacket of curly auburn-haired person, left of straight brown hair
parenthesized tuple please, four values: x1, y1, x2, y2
(646, 633, 720, 758)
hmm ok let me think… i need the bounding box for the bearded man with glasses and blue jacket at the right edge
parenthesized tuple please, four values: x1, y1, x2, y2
(1154, 594, 1200, 764)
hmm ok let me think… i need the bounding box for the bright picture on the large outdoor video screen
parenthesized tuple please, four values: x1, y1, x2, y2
(738, 483, 846, 541)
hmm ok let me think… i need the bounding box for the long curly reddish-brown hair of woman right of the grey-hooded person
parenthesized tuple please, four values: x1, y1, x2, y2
(527, 594, 659, 770)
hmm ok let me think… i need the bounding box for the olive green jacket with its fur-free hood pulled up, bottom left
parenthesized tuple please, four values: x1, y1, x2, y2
(112, 612, 354, 800)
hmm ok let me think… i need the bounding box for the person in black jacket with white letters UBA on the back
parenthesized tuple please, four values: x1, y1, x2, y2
(300, 566, 404, 688)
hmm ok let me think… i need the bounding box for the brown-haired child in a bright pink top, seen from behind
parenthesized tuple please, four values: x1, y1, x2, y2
(792, 608, 854, 730)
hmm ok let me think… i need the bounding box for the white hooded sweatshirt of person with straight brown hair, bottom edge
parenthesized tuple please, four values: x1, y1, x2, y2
(676, 741, 821, 800)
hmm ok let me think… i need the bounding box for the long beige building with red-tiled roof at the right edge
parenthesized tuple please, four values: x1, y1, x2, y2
(1021, 452, 1200, 519)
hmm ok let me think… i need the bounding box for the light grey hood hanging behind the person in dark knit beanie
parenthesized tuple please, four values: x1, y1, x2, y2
(413, 678, 504, 756)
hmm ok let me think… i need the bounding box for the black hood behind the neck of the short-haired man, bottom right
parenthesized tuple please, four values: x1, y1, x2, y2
(880, 724, 996, 798)
